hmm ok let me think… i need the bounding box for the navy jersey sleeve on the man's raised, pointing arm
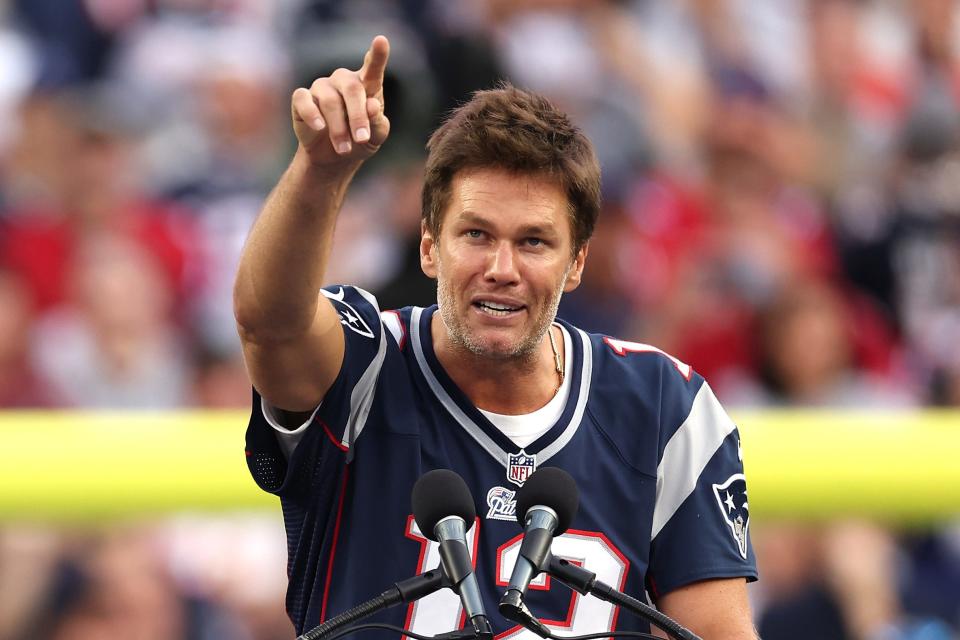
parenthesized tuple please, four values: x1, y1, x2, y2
(246, 286, 388, 493)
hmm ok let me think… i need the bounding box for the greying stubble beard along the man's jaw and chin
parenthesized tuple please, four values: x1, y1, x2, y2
(437, 268, 570, 364)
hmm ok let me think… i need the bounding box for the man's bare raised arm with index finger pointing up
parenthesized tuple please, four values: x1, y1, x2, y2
(233, 36, 390, 411)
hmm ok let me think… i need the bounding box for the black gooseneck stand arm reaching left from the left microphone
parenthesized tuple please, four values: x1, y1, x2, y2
(297, 567, 493, 640)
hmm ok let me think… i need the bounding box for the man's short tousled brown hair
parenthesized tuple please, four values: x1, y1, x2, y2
(420, 83, 600, 253)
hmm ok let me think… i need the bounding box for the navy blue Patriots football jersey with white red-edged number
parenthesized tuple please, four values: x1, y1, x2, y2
(247, 287, 757, 638)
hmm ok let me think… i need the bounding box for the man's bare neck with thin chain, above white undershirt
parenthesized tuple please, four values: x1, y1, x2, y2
(430, 313, 565, 415)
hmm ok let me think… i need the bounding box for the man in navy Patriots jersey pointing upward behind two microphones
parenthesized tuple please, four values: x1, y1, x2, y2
(235, 36, 756, 639)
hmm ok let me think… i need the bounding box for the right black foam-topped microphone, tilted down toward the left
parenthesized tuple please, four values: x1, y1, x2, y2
(499, 467, 580, 638)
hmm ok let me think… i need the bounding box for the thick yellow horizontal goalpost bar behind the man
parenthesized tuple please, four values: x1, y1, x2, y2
(0, 411, 960, 526)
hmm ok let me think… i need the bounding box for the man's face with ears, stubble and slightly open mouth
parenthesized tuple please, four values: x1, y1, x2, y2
(420, 169, 587, 359)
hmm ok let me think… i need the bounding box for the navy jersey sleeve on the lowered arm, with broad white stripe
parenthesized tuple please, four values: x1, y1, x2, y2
(647, 375, 757, 598)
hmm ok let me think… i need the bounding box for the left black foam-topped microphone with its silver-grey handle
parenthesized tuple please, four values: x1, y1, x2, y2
(411, 469, 493, 639)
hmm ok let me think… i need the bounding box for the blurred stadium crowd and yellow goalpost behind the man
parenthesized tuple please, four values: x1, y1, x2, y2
(0, 0, 960, 640)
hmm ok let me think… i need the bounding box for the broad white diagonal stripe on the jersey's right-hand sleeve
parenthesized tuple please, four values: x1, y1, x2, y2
(650, 382, 736, 540)
